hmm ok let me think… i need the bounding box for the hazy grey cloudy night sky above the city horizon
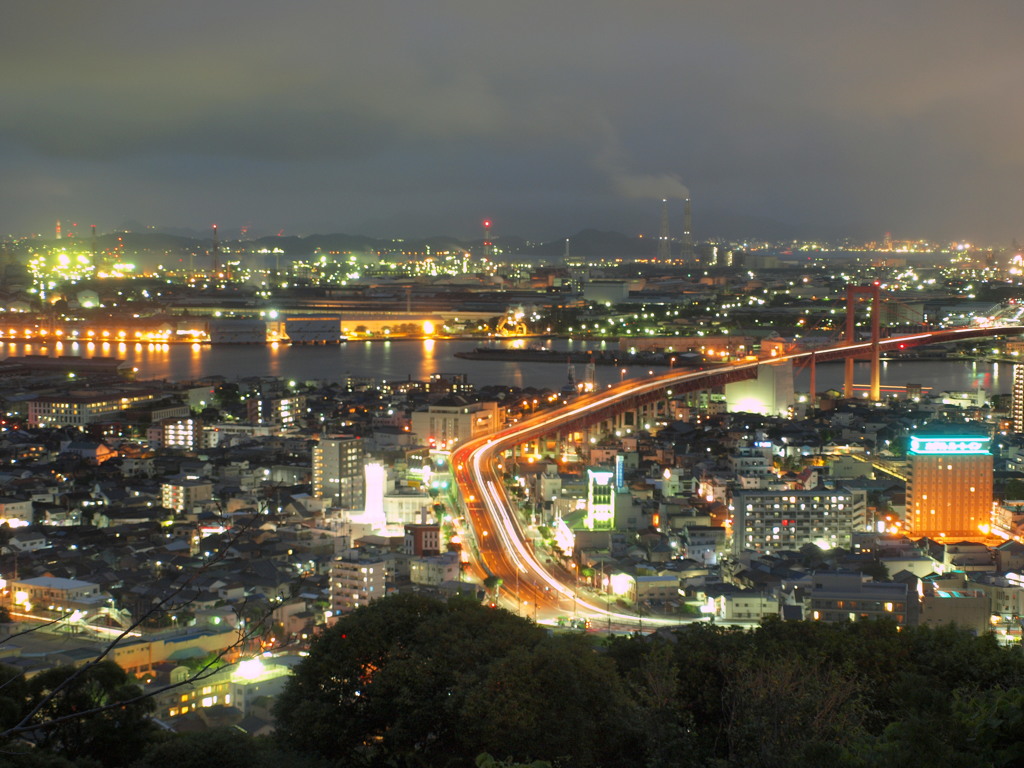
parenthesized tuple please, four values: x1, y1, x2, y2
(0, 0, 1024, 245)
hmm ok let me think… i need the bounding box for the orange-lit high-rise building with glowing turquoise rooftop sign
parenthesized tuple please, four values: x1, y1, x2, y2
(906, 428, 992, 539)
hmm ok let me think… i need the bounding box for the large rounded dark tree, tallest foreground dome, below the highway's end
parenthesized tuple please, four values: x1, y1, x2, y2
(276, 595, 546, 765)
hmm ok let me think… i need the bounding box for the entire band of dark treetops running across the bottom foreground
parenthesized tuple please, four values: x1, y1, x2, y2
(6, 595, 1024, 768)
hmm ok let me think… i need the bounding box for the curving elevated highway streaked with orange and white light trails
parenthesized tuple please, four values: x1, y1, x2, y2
(452, 326, 1024, 626)
